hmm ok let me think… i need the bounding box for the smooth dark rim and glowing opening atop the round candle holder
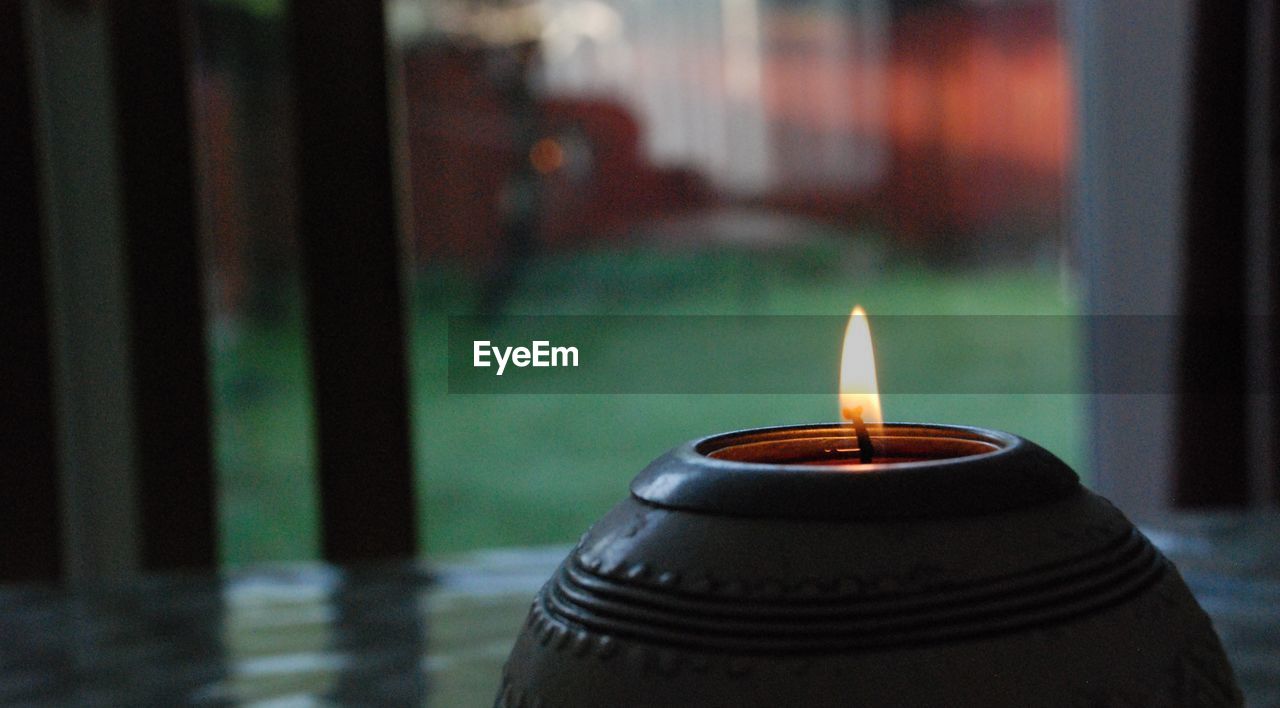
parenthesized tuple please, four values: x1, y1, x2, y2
(631, 422, 1080, 520)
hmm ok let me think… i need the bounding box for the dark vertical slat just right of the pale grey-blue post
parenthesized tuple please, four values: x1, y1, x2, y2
(1174, 0, 1249, 507)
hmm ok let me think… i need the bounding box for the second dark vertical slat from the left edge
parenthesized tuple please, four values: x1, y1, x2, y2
(108, 0, 218, 570)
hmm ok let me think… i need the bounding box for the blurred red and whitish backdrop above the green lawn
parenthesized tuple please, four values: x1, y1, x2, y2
(201, 0, 1073, 311)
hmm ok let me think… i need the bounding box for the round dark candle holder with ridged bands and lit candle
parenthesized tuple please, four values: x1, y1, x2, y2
(497, 424, 1242, 708)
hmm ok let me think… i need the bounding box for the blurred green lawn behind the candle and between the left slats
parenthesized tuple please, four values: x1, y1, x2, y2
(214, 247, 1088, 563)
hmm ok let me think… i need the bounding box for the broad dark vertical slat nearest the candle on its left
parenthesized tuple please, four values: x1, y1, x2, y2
(289, 0, 416, 562)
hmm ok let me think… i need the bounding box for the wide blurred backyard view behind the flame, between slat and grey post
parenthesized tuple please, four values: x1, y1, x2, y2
(389, 0, 1084, 552)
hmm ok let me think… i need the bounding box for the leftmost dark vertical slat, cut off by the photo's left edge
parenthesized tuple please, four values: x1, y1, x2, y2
(0, 0, 61, 581)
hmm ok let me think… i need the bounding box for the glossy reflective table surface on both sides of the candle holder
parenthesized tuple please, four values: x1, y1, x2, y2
(0, 515, 1280, 708)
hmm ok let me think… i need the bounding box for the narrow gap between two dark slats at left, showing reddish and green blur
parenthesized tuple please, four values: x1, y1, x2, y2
(192, 0, 319, 563)
